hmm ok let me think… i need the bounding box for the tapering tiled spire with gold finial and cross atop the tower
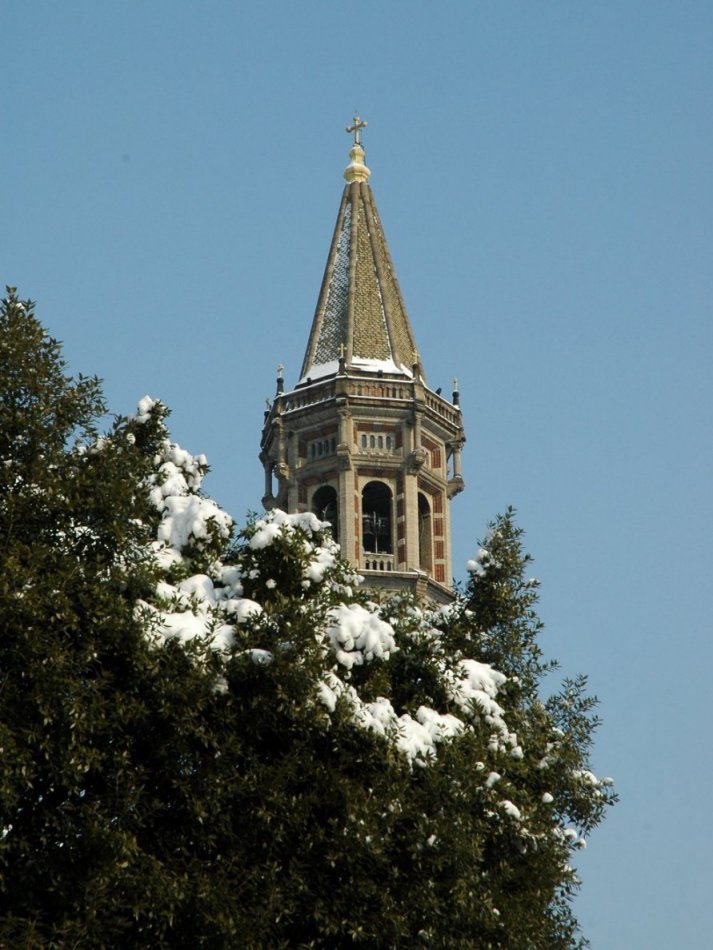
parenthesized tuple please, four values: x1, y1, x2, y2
(302, 116, 418, 381)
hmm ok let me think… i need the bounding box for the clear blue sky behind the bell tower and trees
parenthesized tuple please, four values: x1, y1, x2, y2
(0, 0, 713, 950)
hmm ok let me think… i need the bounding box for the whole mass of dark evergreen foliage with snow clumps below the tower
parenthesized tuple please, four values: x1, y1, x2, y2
(0, 291, 614, 950)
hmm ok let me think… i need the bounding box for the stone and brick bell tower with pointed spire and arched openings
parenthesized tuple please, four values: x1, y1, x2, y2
(260, 116, 465, 603)
